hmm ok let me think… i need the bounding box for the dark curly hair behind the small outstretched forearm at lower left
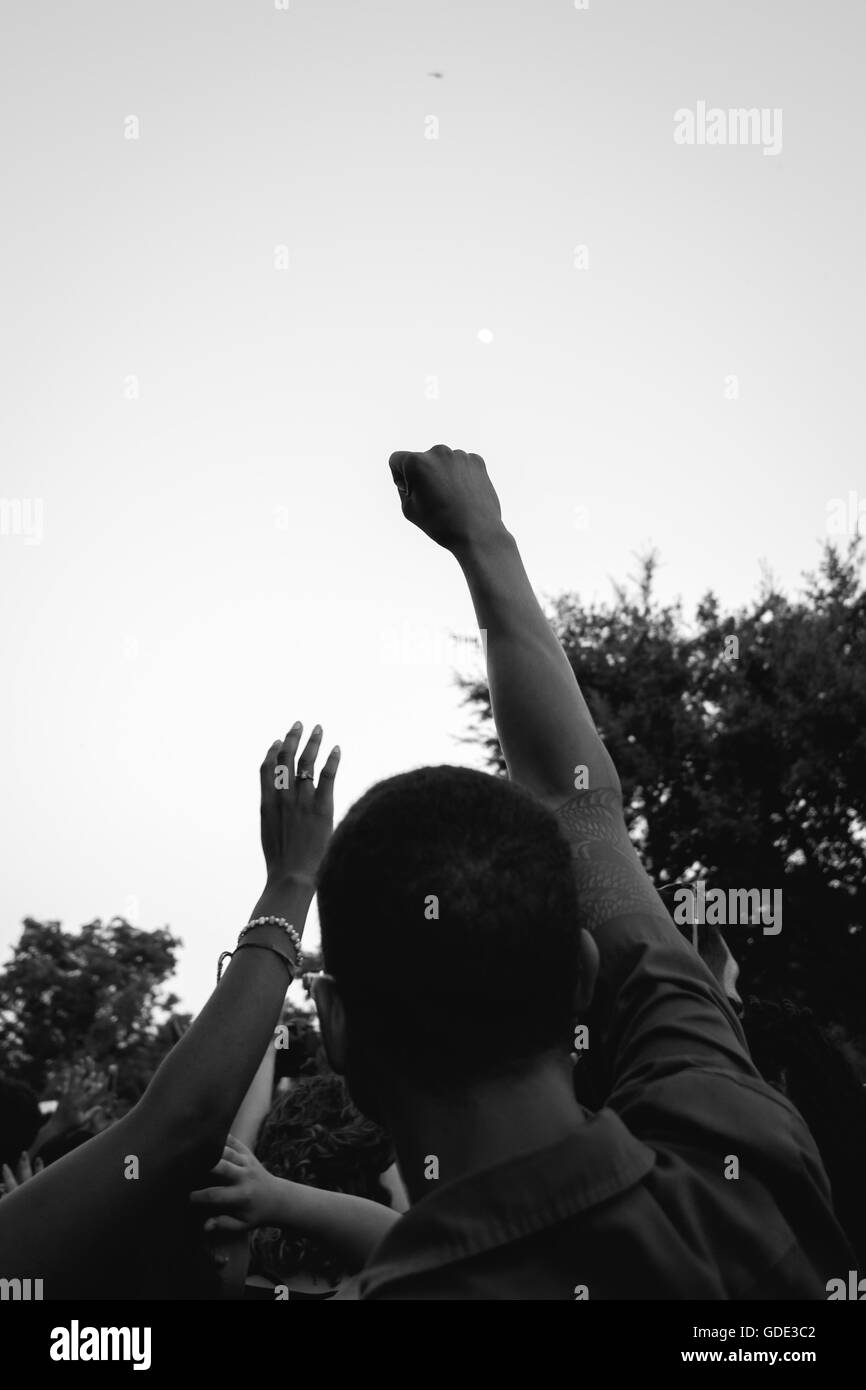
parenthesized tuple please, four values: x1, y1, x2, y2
(250, 1074, 395, 1283)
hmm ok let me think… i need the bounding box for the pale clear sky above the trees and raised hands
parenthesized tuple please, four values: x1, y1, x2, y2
(0, 0, 866, 1011)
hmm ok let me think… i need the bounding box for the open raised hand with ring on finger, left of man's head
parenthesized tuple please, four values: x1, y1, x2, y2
(261, 723, 341, 884)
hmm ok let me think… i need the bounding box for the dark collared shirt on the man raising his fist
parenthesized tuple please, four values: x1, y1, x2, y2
(360, 913, 852, 1300)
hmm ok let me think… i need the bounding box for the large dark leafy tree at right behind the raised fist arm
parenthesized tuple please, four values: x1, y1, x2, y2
(460, 539, 866, 1052)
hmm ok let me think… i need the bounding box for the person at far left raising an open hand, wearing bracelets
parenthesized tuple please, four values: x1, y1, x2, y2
(0, 723, 339, 1300)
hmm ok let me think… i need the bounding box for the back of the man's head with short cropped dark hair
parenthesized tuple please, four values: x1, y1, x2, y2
(316, 767, 595, 1115)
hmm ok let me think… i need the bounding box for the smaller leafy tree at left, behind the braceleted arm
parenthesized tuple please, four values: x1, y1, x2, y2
(0, 917, 189, 1116)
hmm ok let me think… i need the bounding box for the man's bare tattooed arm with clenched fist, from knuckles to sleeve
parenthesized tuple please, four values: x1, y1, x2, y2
(391, 446, 667, 928)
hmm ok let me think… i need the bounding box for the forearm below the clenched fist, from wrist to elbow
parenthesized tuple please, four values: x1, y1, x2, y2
(455, 527, 620, 803)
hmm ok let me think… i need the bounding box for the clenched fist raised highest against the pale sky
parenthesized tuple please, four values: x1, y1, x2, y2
(388, 443, 502, 550)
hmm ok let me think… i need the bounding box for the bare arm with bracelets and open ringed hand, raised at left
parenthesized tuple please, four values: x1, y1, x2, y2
(0, 726, 338, 1298)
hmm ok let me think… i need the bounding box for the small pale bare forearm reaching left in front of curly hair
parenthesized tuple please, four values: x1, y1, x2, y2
(268, 1177, 399, 1272)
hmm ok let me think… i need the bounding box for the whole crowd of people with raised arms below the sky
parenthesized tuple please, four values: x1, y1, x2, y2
(0, 446, 866, 1301)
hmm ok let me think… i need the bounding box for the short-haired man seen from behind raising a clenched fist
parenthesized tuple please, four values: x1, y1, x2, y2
(304, 446, 852, 1300)
